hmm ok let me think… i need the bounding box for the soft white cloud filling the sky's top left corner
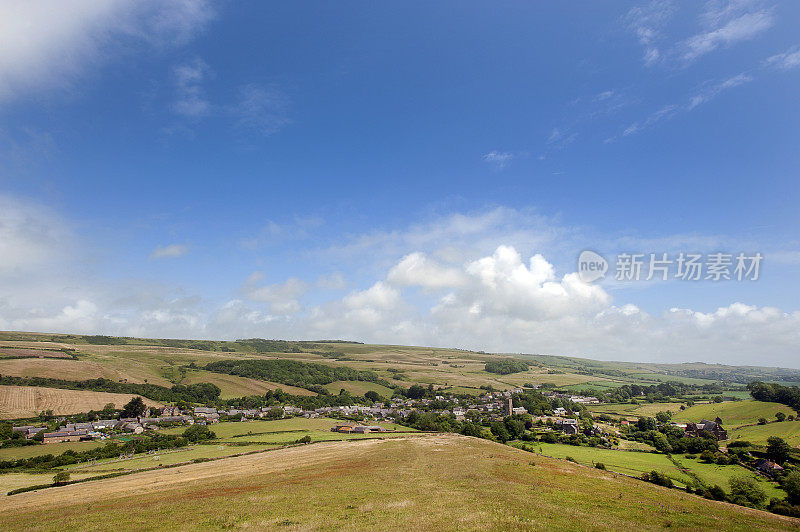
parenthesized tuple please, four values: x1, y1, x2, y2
(0, 0, 213, 100)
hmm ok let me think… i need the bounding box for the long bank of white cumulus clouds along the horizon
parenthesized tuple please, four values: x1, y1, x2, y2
(0, 193, 800, 366)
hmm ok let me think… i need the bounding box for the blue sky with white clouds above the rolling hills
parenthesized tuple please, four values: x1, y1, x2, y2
(0, 0, 800, 367)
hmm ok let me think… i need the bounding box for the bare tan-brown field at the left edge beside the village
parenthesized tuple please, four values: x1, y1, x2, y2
(0, 386, 161, 419)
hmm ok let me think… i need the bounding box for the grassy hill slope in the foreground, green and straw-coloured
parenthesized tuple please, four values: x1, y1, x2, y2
(0, 436, 794, 530)
